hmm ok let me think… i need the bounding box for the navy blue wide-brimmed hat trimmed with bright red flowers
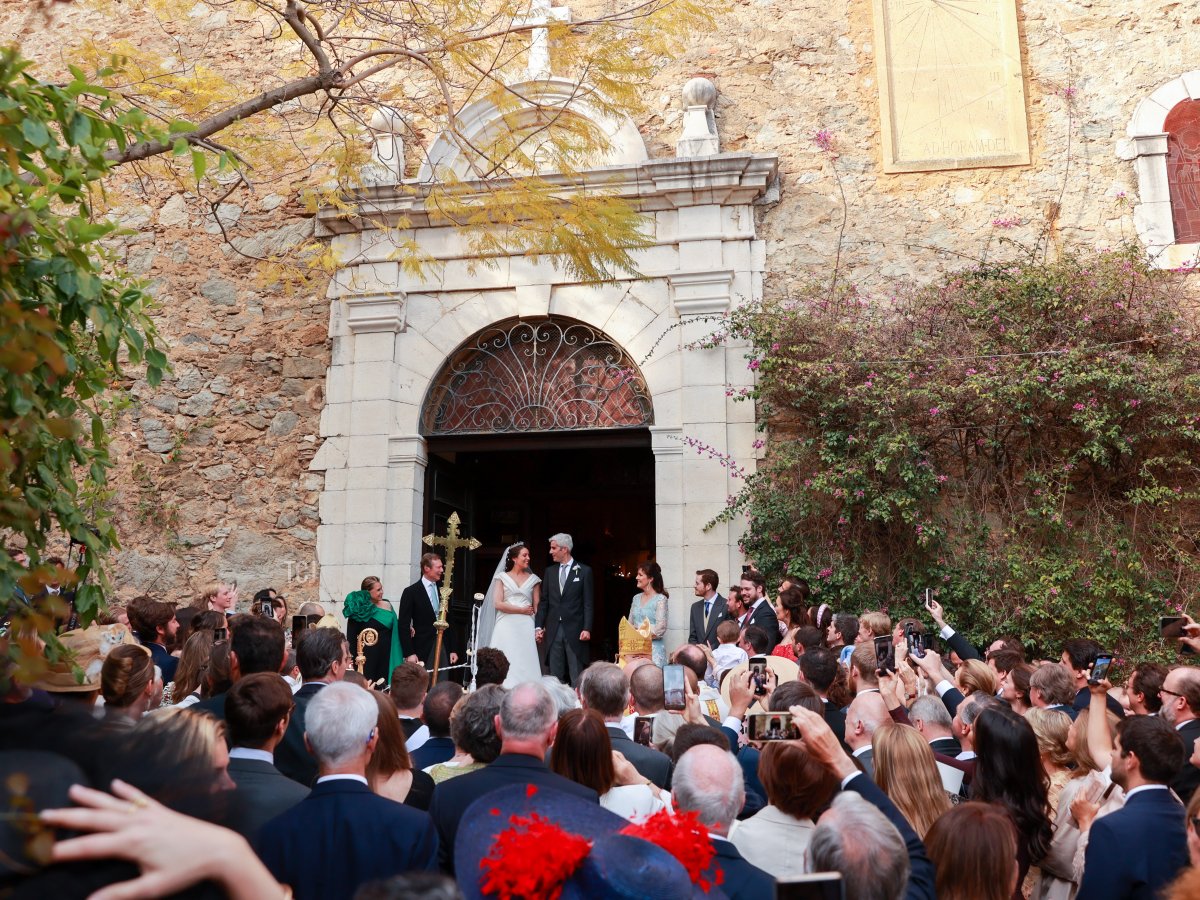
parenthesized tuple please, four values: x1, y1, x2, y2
(454, 785, 725, 900)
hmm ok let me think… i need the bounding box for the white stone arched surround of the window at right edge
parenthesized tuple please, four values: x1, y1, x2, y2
(1126, 70, 1200, 269)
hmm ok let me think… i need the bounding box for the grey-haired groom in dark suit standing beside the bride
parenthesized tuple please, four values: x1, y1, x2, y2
(534, 534, 595, 685)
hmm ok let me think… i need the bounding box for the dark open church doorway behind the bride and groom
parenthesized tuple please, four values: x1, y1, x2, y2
(425, 428, 654, 672)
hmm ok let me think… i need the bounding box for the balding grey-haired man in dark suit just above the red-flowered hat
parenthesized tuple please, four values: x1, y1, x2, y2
(430, 682, 599, 875)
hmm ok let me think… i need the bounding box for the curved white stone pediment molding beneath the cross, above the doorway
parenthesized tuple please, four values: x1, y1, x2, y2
(416, 77, 649, 184)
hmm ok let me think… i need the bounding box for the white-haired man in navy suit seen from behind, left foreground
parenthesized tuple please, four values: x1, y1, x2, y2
(258, 682, 438, 900)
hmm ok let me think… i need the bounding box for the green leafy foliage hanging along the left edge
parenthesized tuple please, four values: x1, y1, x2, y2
(0, 49, 167, 692)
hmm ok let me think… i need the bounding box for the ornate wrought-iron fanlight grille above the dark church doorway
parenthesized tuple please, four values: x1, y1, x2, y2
(421, 319, 654, 436)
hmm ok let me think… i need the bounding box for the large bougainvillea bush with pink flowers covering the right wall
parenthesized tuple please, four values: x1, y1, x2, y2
(714, 251, 1200, 658)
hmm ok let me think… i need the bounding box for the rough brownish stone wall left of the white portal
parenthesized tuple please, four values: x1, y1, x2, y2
(0, 4, 329, 604)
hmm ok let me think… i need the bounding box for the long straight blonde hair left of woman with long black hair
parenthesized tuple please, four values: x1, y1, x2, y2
(871, 722, 950, 838)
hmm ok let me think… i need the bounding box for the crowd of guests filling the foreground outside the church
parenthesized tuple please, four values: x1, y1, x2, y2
(0, 569, 1200, 900)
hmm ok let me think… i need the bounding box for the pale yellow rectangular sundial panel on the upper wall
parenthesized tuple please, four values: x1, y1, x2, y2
(875, 0, 1030, 172)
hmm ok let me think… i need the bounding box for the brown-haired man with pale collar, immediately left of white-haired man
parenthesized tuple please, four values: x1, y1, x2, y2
(226, 672, 308, 844)
